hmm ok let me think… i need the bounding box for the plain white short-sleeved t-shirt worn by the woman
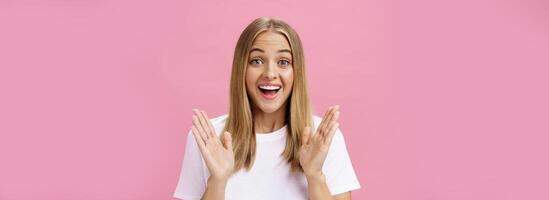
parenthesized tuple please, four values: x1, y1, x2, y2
(174, 115, 360, 200)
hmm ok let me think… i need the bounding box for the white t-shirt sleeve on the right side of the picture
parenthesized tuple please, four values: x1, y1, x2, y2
(322, 128, 360, 195)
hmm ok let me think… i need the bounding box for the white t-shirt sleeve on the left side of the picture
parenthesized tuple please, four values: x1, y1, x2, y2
(174, 132, 206, 200)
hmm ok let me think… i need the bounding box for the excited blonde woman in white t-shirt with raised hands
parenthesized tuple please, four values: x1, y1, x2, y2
(174, 18, 360, 200)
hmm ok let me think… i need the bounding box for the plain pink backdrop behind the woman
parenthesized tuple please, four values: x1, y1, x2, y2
(0, 0, 549, 200)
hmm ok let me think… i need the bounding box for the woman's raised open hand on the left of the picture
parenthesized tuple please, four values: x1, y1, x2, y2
(192, 109, 234, 182)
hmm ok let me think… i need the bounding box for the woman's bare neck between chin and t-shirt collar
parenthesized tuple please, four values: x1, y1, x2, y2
(252, 104, 286, 133)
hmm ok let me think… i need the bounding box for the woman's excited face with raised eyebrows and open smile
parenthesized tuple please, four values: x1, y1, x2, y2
(246, 31, 294, 113)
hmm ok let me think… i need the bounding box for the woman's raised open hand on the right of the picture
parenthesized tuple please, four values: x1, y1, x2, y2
(299, 106, 339, 177)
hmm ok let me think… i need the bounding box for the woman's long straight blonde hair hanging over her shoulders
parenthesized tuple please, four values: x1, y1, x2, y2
(224, 17, 313, 172)
